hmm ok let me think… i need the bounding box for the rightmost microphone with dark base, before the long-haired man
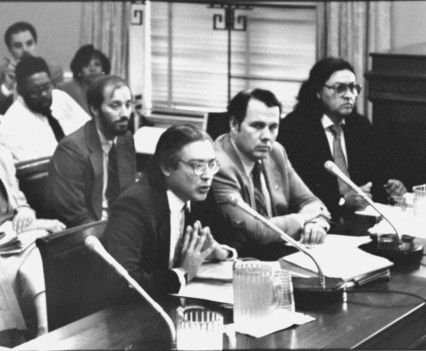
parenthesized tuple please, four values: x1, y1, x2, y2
(324, 160, 423, 264)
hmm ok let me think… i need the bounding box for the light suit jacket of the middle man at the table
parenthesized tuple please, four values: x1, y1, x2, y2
(213, 134, 327, 256)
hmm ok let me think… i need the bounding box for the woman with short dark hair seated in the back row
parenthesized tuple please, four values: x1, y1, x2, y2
(57, 45, 111, 114)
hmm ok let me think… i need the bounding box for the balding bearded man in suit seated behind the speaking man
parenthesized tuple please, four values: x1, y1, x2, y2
(45, 75, 136, 227)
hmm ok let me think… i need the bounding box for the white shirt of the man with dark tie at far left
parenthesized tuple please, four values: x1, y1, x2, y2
(0, 89, 91, 162)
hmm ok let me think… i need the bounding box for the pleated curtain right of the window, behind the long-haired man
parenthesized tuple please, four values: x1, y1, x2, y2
(317, 1, 392, 113)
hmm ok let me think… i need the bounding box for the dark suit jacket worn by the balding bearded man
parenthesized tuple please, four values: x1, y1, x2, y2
(46, 121, 136, 227)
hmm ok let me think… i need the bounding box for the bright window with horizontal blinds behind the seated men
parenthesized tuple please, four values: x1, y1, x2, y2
(151, 2, 316, 113)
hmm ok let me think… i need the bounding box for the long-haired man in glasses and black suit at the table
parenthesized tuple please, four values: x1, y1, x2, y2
(277, 57, 406, 233)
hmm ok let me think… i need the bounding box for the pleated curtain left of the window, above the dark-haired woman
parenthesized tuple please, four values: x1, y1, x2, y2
(80, 1, 131, 80)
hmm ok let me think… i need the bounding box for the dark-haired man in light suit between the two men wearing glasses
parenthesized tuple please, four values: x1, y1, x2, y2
(212, 89, 329, 259)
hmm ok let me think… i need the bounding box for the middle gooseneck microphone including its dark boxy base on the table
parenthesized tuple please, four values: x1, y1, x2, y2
(227, 195, 345, 306)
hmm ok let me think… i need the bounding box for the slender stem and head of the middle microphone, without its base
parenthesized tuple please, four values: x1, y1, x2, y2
(228, 195, 326, 289)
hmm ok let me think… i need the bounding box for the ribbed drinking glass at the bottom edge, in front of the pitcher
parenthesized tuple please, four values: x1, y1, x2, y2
(176, 306, 223, 350)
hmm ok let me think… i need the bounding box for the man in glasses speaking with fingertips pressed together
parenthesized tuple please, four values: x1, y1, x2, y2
(104, 125, 236, 299)
